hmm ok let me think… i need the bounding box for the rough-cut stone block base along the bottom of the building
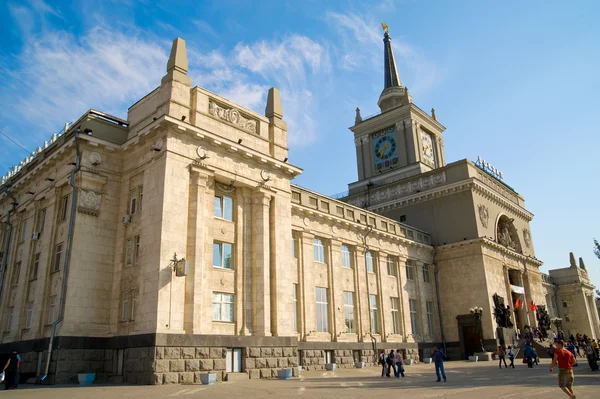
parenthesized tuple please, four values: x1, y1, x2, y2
(0, 334, 427, 385)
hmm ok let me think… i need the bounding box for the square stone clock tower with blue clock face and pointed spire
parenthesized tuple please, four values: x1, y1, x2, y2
(349, 24, 445, 194)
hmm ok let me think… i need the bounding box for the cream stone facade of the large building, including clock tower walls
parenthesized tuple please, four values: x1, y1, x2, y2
(0, 28, 596, 384)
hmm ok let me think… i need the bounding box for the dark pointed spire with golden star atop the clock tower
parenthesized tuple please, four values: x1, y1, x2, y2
(377, 22, 412, 112)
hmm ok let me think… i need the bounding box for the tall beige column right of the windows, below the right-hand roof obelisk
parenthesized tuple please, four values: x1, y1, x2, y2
(252, 190, 271, 336)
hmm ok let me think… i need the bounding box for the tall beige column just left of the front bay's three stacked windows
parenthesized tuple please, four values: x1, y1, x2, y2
(183, 169, 208, 334)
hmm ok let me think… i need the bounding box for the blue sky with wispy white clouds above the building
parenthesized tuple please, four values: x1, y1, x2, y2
(0, 0, 600, 285)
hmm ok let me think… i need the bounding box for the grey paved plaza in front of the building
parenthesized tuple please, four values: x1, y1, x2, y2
(2, 359, 600, 399)
